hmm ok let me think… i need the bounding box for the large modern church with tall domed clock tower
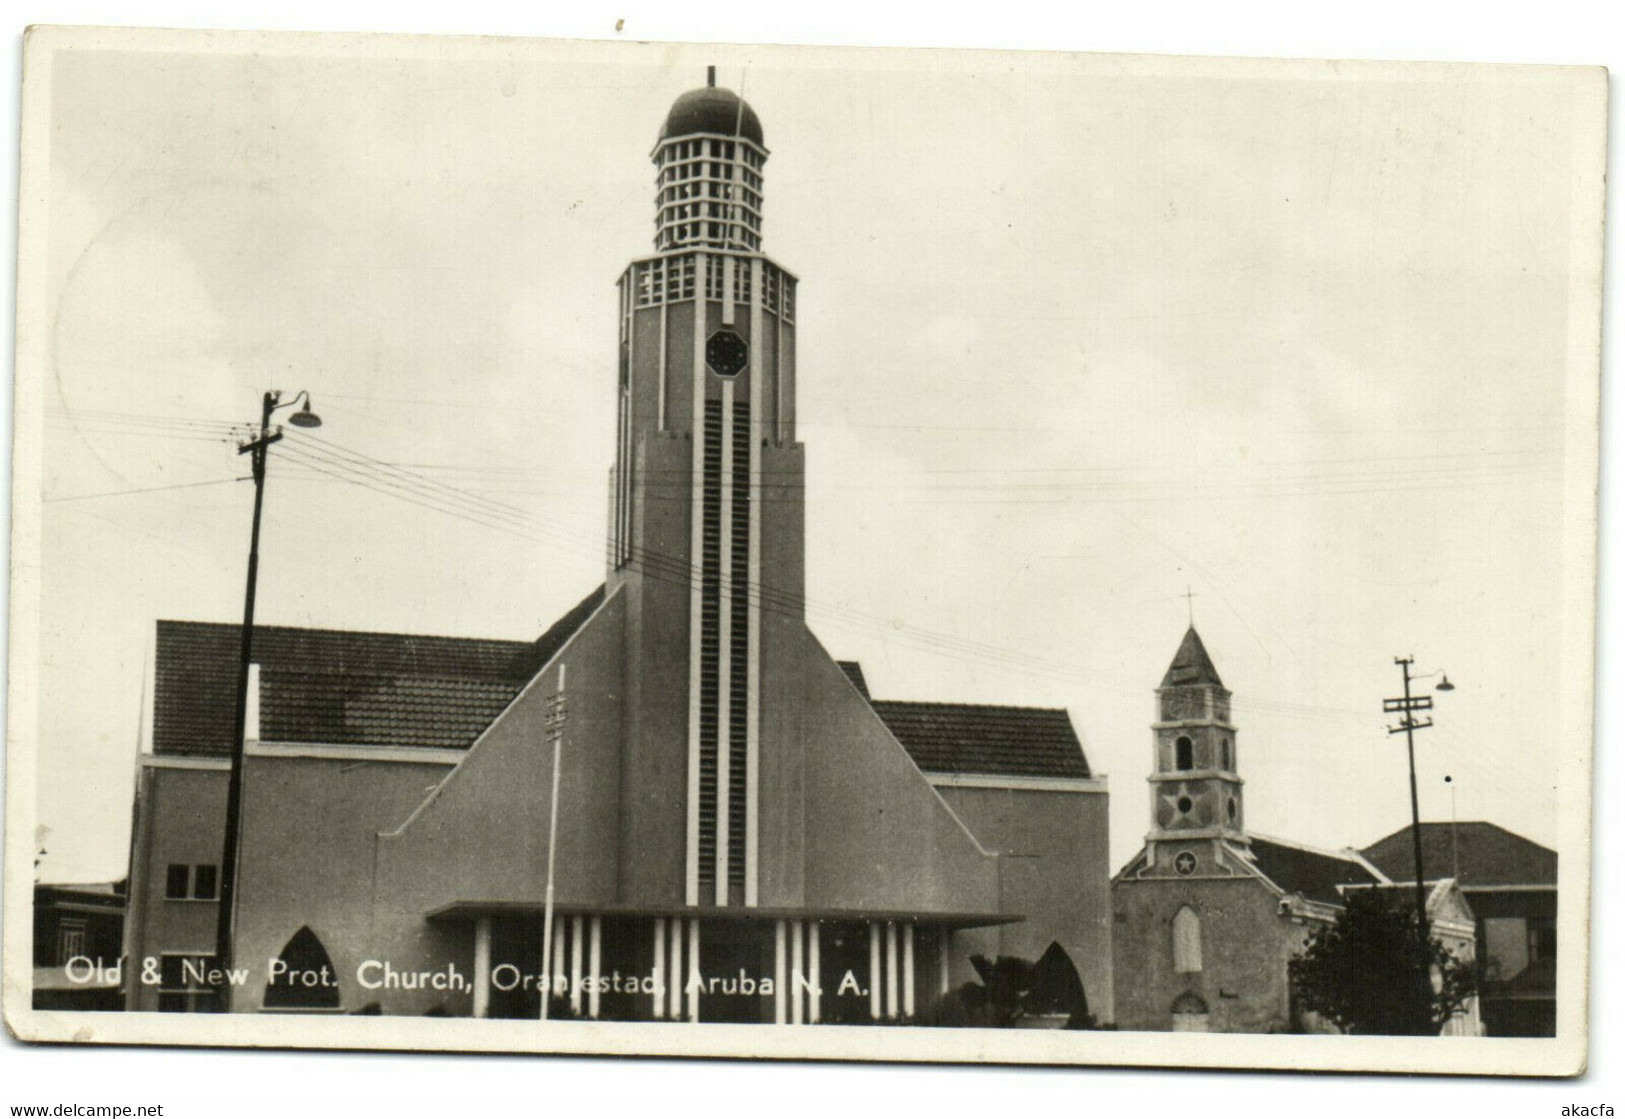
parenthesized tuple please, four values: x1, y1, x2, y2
(125, 74, 1118, 1023)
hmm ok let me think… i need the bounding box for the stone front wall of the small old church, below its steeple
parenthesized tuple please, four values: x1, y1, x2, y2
(1112, 879, 1308, 1033)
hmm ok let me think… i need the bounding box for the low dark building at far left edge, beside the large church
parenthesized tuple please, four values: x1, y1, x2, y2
(33, 882, 124, 1010)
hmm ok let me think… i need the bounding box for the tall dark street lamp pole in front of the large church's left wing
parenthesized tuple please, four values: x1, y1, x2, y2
(215, 390, 322, 1010)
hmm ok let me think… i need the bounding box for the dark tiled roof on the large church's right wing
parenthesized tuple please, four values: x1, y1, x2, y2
(869, 700, 1090, 778)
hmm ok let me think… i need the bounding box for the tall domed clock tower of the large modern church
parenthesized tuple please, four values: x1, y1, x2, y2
(606, 67, 804, 906)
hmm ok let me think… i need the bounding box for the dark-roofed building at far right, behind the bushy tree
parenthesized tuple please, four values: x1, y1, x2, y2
(1363, 820, 1557, 1038)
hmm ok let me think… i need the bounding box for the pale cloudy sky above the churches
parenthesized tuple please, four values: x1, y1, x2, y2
(20, 41, 1596, 880)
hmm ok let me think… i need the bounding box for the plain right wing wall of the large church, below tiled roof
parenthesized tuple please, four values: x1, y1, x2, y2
(941, 788, 1113, 1022)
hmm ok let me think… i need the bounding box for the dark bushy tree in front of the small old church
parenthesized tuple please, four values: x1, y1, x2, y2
(1292, 890, 1474, 1036)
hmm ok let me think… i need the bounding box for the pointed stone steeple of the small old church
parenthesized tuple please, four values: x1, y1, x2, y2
(1146, 625, 1248, 877)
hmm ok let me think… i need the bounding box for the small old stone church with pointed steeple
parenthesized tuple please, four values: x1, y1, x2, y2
(1112, 627, 1471, 1033)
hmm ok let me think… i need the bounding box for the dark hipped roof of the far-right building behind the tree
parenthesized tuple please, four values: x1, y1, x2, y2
(1362, 820, 1557, 888)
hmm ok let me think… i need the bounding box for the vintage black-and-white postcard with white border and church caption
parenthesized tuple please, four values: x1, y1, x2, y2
(5, 28, 1607, 1075)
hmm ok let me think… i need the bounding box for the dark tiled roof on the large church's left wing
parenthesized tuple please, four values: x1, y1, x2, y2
(153, 586, 603, 755)
